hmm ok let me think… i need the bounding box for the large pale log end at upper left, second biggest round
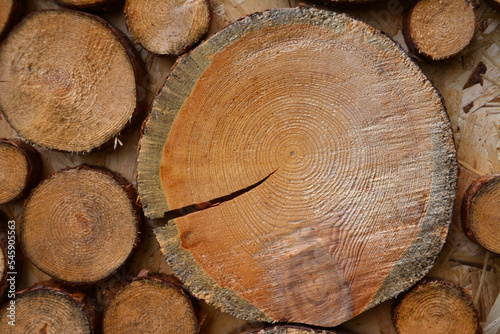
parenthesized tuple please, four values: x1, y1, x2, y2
(0, 11, 136, 151)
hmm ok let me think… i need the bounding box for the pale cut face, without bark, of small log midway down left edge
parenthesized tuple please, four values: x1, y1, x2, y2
(0, 142, 29, 203)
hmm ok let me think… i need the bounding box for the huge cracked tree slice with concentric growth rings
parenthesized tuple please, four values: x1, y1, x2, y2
(138, 8, 457, 326)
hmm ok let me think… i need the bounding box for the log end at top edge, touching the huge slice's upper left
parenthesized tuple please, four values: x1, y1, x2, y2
(124, 0, 210, 55)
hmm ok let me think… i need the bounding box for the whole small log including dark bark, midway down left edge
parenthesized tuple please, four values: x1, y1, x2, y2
(0, 139, 42, 204)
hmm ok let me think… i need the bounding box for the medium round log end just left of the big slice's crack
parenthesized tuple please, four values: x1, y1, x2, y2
(20, 168, 138, 283)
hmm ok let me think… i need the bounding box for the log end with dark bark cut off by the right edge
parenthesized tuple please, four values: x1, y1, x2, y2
(461, 175, 500, 254)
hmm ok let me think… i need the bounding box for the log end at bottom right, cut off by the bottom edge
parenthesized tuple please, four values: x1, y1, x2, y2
(393, 280, 482, 334)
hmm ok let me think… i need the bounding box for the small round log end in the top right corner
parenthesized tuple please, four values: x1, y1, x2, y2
(403, 0, 476, 61)
